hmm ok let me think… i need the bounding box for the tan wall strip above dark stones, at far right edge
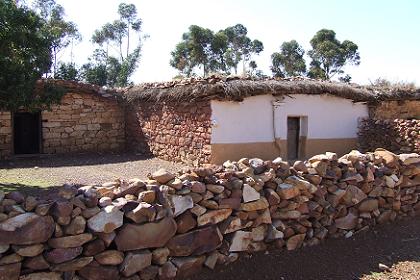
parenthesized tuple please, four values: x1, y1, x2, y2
(369, 100, 420, 119)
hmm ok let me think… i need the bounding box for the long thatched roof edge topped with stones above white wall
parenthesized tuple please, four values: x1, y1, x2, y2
(125, 76, 420, 102)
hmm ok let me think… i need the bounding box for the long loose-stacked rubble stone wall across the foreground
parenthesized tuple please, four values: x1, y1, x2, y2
(0, 150, 420, 280)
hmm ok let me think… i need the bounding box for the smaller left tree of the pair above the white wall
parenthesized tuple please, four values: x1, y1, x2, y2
(270, 40, 306, 78)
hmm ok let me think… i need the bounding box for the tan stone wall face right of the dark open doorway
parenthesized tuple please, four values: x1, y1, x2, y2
(42, 93, 125, 153)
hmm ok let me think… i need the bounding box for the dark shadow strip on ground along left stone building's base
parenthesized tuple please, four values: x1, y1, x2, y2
(0, 153, 151, 169)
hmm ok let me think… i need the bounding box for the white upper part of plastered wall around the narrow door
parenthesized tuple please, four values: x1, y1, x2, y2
(211, 94, 368, 144)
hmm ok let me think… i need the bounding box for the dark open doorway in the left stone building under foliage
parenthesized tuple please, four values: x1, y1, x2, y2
(13, 112, 41, 155)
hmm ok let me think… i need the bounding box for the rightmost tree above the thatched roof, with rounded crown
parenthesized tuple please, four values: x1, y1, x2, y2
(308, 29, 360, 81)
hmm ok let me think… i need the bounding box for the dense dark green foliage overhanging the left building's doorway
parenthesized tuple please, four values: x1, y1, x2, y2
(0, 0, 63, 111)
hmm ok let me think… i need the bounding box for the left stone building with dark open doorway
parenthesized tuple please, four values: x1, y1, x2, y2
(0, 81, 125, 158)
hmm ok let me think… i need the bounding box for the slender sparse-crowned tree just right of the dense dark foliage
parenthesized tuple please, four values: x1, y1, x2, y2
(34, 0, 81, 77)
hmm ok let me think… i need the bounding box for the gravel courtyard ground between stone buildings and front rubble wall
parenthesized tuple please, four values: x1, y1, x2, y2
(0, 154, 182, 190)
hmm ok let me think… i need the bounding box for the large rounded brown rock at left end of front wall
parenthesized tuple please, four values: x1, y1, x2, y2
(0, 213, 55, 245)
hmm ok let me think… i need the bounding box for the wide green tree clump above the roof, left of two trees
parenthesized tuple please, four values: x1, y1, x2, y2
(169, 24, 264, 76)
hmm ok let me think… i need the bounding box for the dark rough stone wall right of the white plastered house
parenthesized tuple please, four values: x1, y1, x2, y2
(358, 119, 420, 153)
